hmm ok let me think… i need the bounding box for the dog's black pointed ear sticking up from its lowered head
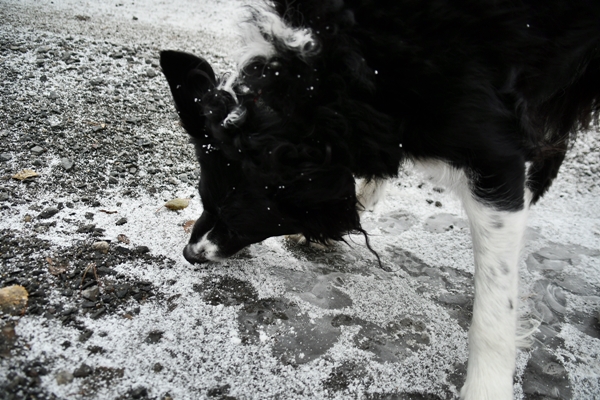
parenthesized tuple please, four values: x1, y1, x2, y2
(160, 50, 216, 137)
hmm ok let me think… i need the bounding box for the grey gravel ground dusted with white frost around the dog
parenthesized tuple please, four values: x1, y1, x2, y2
(0, 0, 600, 399)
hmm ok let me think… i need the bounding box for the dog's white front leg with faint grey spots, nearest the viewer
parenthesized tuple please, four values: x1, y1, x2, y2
(461, 196, 527, 400)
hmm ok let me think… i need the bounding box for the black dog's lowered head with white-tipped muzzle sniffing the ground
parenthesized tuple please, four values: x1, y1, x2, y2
(161, 3, 398, 263)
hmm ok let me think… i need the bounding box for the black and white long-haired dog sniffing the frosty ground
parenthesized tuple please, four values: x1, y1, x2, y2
(161, 0, 600, 400)
